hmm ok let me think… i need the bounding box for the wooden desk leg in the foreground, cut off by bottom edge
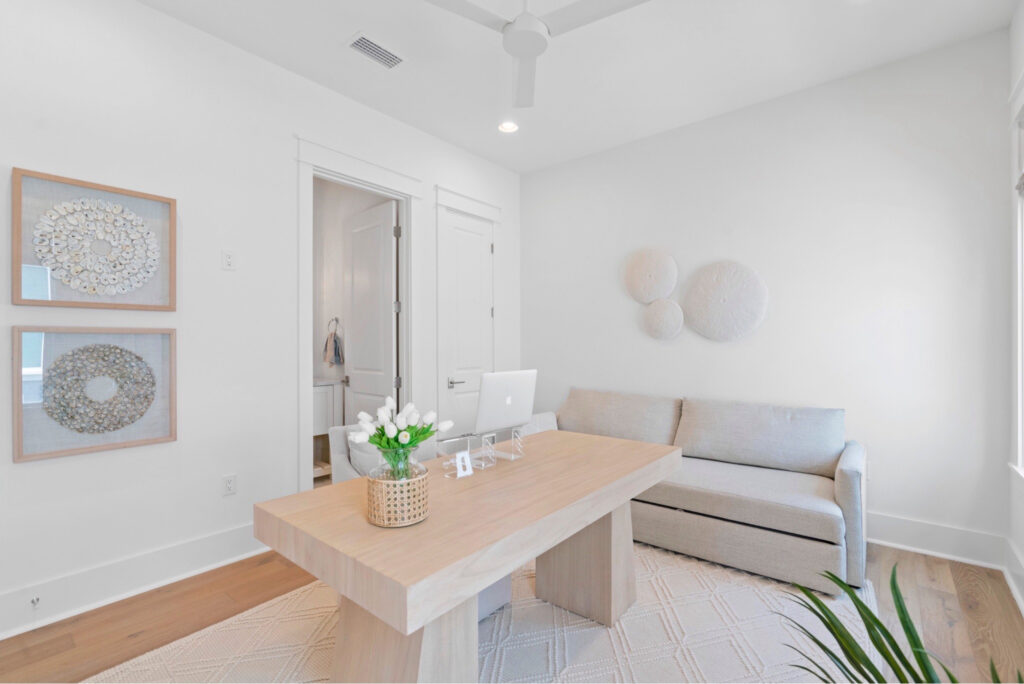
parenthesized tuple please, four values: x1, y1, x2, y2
(331, 596, 478, 682)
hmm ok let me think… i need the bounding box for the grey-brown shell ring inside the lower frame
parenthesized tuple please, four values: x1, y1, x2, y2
(43, 344, 157, 434)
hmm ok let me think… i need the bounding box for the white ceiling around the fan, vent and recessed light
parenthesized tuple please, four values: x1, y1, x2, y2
(141, 0, 1015, 171)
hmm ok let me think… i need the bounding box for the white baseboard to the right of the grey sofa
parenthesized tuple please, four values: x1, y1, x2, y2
(867, 512, 1024, 614)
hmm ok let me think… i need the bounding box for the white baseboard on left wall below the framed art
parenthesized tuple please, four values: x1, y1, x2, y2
(0, 522, 266, 639)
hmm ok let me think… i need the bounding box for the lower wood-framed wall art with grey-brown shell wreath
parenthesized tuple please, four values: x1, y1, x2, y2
(12, 327, 177, 463)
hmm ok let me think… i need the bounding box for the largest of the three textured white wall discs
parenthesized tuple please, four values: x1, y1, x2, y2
(683, 261, 768, 342)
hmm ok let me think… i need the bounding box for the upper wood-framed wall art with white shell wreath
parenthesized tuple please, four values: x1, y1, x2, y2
(11, 169, 176, 311)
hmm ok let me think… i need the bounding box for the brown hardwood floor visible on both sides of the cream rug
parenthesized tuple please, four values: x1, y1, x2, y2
(0, 545, 1024, 682)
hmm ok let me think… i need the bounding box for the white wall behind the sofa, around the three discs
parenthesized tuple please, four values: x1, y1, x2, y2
(521, 32, 1012, 558)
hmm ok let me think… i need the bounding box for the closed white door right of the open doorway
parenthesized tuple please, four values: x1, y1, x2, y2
(437, 207, 495, 435)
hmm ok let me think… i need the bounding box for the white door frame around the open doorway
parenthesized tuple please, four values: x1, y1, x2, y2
(296, 136, 426, 491)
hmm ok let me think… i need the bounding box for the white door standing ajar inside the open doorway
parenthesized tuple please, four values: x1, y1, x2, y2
(342, 200, 398, 425)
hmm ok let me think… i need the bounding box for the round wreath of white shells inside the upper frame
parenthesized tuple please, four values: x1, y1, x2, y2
(33, 198, 160, 296)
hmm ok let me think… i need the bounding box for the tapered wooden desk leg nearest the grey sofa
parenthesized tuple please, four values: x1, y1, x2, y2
(537, 503, 637, 627)
